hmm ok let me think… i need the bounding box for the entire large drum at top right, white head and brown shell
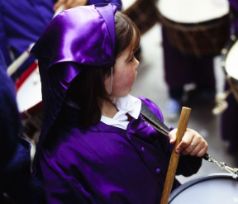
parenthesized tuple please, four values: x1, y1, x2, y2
(158, 0, 230, 56)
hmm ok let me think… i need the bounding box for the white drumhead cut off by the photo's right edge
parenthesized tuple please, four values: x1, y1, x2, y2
(225, 41, 238, 80)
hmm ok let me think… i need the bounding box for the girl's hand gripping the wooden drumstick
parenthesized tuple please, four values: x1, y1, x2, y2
(169, 128, 208, 157)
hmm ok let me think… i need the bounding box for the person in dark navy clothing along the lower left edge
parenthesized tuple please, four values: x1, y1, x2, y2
(0, 52, 32, 204)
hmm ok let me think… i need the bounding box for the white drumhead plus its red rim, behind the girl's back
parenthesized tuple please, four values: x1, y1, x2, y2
(16, 64, 42, 113)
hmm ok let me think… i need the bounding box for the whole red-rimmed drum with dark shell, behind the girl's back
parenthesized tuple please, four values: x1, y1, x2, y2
(16, 63, 42, 142)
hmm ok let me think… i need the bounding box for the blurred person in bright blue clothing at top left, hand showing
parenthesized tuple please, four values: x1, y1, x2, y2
(0, 0, 121, 80)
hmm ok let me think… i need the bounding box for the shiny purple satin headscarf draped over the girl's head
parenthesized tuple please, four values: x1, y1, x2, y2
(32, 4, 117, 143)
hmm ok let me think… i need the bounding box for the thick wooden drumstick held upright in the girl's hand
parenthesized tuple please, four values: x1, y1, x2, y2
(160, 107, 191, 204)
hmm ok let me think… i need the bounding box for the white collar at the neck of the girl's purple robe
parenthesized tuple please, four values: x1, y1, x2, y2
(101, 95, 141, 130)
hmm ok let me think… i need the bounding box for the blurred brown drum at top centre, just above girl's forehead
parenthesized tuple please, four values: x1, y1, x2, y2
(122, 0, 159, 34)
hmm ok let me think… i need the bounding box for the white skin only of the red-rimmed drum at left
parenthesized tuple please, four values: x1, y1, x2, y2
(17, 68, 42, 113)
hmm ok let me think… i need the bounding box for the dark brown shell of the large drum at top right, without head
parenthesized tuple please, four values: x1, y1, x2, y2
(160, 14, 230, 57)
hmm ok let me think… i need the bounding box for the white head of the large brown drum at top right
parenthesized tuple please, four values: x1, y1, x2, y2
(158, 0, 229, 23)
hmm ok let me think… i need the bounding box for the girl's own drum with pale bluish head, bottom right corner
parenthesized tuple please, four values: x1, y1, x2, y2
(169, 174, 238, 204)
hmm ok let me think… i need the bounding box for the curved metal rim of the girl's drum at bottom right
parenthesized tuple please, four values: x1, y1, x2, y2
(169, 173, 238, 203)
